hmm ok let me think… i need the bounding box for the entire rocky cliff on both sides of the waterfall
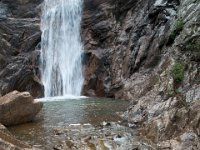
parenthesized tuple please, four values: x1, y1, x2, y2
(0, 0, 200, 149)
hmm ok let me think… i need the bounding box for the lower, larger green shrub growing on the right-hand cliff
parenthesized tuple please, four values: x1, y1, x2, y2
(171, 62, 185, 83)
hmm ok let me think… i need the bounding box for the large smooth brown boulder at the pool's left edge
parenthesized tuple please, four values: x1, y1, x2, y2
(0, 91, 43, 126)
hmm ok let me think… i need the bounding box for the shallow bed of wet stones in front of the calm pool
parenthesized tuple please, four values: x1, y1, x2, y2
(54, 122, 153, 150)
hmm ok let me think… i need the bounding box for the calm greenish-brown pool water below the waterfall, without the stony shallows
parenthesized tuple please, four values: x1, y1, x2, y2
(9, 98, 129, 147)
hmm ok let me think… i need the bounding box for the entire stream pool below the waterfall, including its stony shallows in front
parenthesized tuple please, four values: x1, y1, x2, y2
(9, 98, 150, 150)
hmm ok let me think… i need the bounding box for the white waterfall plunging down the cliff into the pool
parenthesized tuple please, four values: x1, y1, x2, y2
(41, 0, 83, 97)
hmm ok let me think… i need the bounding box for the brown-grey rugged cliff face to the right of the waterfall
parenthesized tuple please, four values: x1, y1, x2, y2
(83, 0, 200, 149)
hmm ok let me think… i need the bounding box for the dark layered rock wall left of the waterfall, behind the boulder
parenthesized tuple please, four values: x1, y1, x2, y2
(0, 0, 43, 97)
